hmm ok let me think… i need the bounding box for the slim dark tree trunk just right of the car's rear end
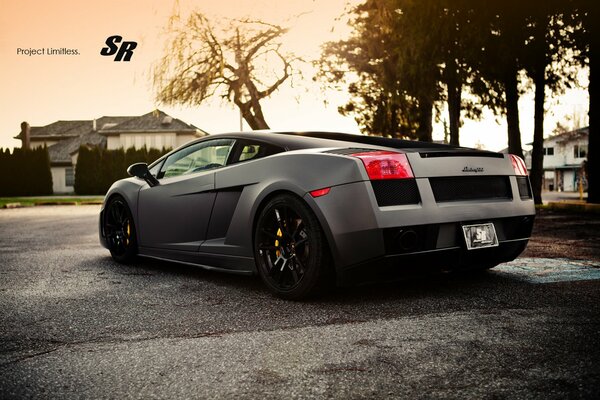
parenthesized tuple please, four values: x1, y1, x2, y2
(530, 65, 546, 204)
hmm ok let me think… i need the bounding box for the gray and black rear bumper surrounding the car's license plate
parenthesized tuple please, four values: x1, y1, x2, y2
(305, 180, 535, 281)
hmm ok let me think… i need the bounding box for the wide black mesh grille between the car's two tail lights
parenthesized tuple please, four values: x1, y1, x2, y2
(429, 176, 512, 203)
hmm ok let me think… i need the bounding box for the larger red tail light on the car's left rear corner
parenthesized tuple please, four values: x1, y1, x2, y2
(352, 151, 414, 181)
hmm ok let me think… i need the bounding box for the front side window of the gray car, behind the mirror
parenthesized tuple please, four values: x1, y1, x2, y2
(157, 139, 234, 179)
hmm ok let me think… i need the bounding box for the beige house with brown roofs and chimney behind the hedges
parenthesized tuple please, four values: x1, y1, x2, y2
(15, 110, 207, 193)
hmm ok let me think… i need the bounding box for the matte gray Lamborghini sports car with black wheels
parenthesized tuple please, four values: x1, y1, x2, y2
(100, 132, 535, 298)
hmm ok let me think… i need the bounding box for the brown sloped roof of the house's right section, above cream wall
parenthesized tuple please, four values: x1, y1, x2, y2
(100, 110, 206, 135)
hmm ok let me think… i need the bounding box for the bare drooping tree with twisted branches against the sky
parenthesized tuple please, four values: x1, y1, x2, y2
(152, 12, 298, 129)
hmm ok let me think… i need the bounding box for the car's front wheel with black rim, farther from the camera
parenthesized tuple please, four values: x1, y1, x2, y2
(103, 196, 137, 264)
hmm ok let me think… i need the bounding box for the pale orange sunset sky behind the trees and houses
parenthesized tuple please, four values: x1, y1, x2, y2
(0, 0, 588, 150)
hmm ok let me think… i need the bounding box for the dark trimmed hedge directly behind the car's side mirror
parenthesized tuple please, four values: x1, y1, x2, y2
(75, 146, 169, 195)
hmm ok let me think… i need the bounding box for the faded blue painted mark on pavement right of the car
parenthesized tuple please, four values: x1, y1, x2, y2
(492, 258, 600, 283)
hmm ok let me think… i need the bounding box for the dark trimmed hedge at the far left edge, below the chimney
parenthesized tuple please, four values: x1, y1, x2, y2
(0, 147, 52, 197)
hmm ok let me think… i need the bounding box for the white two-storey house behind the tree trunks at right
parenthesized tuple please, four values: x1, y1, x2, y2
(525, 127, 589, 192)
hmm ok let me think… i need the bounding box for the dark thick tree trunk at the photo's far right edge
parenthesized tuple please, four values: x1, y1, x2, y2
(587, 19, 600, 203)
